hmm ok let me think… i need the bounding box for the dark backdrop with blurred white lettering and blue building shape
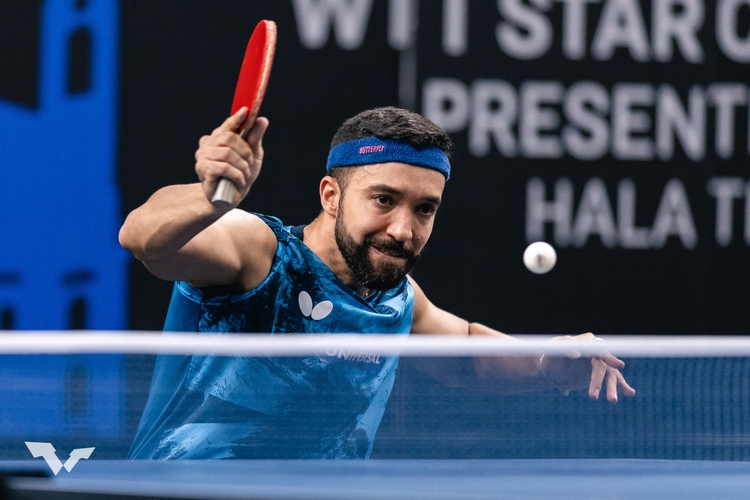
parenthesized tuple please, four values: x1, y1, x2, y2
(0, 0, 750, 334)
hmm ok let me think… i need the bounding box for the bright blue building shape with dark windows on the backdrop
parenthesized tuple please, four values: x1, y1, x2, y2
(0, 0, 128, 330)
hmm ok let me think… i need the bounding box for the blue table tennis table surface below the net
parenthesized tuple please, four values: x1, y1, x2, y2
(3, 459, 750, 500)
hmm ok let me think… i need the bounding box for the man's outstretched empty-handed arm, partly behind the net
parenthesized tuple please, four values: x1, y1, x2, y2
(409, 277, 635, 403)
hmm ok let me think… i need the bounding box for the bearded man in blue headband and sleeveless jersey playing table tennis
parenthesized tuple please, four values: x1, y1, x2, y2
(120, 108, 634, 458)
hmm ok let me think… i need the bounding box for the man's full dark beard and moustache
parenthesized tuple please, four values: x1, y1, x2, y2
(334, 206, 419, 290)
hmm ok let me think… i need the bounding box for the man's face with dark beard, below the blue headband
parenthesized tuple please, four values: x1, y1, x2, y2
(335, 163, 445, 290)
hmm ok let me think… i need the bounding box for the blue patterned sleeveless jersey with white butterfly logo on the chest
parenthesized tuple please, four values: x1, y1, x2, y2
(129, 215, 414, 459)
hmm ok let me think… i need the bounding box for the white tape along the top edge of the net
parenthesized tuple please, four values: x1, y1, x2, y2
(0, 331, 750, 358)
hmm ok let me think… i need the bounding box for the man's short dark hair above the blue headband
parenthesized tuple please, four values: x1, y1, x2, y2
(329, 106, 453, 194)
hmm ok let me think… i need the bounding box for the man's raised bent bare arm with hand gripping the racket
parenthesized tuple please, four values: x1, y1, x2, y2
(120, 108, 276, 290)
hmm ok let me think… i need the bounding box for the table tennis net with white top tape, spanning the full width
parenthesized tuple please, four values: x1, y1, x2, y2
(0, 332, 750, 462)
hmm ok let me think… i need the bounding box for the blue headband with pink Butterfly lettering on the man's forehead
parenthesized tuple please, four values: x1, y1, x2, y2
(326, 137, 451, 181)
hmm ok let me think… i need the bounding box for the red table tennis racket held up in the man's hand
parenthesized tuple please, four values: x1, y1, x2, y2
(211, 20, 276, 206)
